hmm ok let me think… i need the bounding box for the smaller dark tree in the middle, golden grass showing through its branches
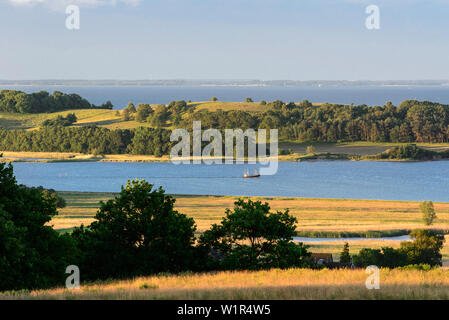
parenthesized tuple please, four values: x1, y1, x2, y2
(200, 199, 309, 270)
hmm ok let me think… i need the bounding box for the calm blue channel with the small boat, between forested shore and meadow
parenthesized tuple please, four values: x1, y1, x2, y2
(14, 161, 449, 202)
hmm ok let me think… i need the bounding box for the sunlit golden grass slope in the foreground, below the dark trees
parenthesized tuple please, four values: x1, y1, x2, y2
(0, 268, 449, 300)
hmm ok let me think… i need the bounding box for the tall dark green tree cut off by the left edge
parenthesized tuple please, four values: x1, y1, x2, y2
(0, 159, 76, 291)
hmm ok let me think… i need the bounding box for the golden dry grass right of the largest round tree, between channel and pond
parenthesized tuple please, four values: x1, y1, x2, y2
(170, 196, 449, 231)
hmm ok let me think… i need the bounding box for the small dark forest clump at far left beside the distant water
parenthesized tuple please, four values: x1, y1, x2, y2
(0, 90, 112, 113)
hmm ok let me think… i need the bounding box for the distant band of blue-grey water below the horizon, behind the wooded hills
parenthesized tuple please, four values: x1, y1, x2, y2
(0, 86, 449, 109)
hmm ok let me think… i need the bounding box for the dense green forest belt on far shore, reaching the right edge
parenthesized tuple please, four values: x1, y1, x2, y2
(177, 100, 449, 143)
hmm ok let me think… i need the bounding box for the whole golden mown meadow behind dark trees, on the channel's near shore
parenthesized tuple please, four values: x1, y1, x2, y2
(51, 192, 449, 265)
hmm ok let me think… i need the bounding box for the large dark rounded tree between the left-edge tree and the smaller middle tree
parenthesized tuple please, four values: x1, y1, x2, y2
(73, 180, 196, 279)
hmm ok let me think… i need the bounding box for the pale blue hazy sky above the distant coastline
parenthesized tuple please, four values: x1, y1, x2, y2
(0, 0, 449, 80)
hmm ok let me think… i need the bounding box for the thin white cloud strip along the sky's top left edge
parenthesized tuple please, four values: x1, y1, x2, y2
(7, 0, 142, 10)
